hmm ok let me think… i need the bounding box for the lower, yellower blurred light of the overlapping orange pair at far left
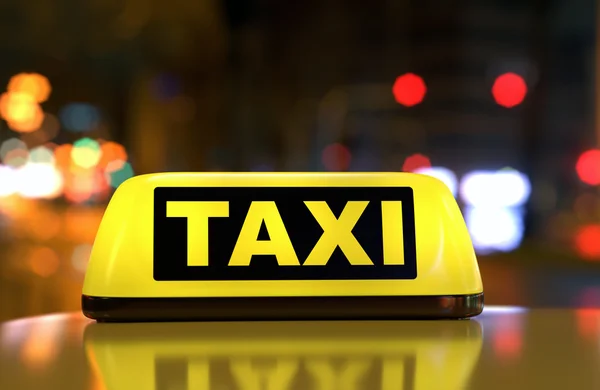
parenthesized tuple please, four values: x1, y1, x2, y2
(0, 92, 44, 133)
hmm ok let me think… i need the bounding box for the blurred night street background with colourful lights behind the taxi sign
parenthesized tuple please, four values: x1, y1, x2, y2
(0, 0, 600, 321)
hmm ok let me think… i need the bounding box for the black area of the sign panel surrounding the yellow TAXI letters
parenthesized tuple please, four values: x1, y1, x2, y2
(154, 187, 417, 281)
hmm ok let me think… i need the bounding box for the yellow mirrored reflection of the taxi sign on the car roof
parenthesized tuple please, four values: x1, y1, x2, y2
(84, 321, 482, 390)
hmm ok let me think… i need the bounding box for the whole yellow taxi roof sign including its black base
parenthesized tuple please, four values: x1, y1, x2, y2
(82, 173, 483, 321)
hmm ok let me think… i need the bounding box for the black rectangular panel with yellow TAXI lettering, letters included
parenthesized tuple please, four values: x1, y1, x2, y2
(153, 187, 417, 281)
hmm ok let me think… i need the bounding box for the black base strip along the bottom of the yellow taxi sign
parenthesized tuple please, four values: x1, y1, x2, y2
(81, 293, 483, 322)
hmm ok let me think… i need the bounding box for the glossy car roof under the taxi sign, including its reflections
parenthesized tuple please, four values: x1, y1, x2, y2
(0, 307, 600, 390)
